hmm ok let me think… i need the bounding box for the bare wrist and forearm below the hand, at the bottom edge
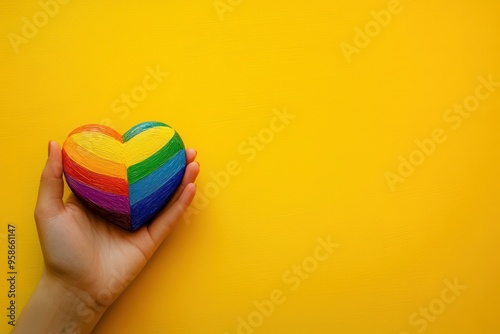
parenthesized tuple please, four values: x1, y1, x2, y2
(12, 273, 106, 334)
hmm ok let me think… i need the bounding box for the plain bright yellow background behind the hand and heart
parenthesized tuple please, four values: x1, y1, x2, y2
(0, 0, 500, 334)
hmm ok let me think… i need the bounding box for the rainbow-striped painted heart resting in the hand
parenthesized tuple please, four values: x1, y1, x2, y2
(62, 122, 186, 231)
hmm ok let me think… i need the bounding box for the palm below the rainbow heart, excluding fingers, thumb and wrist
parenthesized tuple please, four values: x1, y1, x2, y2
(40, 195, 150, 296)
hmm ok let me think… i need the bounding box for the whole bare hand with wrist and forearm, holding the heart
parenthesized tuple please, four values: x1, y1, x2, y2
(12, 141, 200, 334)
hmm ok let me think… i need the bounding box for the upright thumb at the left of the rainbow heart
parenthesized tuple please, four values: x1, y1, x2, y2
(35, 141, 64, 223)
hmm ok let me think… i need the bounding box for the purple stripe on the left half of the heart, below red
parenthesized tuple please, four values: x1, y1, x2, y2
(65, 174, 130, 214)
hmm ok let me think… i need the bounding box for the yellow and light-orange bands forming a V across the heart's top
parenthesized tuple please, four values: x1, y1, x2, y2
(66, 126, 175, 179)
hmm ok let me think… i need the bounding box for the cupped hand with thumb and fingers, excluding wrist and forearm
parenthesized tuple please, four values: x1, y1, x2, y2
(35, 143, 199, 304)
